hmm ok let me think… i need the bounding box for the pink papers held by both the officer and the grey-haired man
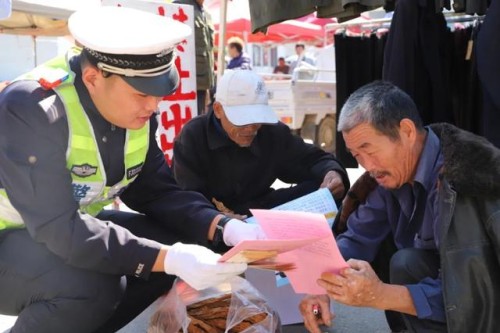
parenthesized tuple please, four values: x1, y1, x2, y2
(221, 210, 348, 295)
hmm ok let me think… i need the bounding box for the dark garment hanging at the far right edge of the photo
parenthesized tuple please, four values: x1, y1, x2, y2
(476, 0, 500, 147)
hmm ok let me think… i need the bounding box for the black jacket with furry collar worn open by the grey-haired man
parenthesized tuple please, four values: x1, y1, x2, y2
(338, 123, 500, 333)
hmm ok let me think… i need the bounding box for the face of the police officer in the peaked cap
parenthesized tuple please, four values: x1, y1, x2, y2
(82, 67, 161, 129)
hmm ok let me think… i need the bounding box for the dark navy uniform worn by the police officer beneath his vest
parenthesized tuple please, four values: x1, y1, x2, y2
(0, 57, 218, 332)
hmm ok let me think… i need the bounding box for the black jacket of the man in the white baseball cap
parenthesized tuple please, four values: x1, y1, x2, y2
(173, 111, 349, 214)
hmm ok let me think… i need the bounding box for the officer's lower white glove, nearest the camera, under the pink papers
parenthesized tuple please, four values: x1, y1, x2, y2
(164, 243, 247, 290)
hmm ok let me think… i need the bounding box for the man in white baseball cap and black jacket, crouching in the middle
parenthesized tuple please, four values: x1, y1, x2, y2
(174, 70, 349, 217)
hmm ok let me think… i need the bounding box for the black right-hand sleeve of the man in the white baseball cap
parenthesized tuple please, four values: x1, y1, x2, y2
(276, 124, 350, 189)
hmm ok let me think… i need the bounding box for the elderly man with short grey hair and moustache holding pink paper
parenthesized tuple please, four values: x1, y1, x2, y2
(301, 82, 500, 333)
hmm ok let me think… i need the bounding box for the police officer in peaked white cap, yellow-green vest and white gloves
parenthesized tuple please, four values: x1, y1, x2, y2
(0, 7, 262, 333)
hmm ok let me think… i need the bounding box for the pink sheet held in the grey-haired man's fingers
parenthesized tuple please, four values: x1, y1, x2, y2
(251, 210, 347, 294)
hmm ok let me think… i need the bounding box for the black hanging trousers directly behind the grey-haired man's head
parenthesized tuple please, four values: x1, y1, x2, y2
(335, 33, 387, 168)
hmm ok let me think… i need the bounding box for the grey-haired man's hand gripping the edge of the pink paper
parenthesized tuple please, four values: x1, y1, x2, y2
(318, 259, 384, 308)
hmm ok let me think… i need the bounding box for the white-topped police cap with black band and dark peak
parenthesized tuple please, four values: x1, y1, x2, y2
(68, 6, 191, 96)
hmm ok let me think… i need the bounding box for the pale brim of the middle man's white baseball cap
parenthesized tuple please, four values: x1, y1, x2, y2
(223, 104, 278, 126)
